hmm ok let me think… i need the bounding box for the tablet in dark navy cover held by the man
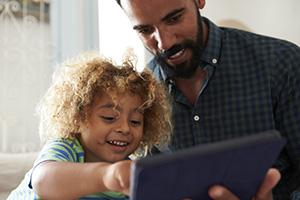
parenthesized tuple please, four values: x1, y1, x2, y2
(130, 130, 286, 200)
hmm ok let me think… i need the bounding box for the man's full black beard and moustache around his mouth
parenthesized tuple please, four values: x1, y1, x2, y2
(154, 11, 203, 79)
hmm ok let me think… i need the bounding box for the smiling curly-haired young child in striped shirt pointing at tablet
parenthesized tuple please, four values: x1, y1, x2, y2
(8, 49, 171, 200)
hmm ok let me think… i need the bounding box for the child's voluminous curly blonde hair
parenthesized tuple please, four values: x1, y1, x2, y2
(37, 50, 172, 157)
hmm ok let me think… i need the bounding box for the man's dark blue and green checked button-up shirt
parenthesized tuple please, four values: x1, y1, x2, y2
(148, 18, 300, 199)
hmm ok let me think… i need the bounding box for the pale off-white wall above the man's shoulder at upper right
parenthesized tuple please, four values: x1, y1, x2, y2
(201, 0, 300, 46)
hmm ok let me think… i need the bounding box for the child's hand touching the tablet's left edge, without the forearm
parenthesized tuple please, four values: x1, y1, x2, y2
(103, 160, 133, 195)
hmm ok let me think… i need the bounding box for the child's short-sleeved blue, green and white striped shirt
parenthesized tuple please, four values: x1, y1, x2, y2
(7, 139, 129, 200)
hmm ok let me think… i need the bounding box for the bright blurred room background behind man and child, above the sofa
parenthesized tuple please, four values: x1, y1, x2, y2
(0, 0, 300, 153)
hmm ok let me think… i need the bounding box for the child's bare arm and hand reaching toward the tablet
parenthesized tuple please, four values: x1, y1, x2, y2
(32, 161, 133, 200)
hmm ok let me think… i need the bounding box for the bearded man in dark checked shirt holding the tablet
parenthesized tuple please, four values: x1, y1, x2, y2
(117, 0, 300, 199)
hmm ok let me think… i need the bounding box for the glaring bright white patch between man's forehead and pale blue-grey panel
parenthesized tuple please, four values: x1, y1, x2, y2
(98, 0, 146, 69)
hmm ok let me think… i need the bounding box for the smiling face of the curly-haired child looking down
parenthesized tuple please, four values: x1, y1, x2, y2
(79, 94, 144, 162)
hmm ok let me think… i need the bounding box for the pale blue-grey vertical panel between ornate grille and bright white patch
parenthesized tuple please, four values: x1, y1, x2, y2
(50, 0, 99, 63)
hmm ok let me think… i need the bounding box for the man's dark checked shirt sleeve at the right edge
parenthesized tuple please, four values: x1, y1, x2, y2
(273, 40, 300, 199)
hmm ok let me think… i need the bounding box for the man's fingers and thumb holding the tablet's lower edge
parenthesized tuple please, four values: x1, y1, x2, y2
(208, 168, 280, 200)
